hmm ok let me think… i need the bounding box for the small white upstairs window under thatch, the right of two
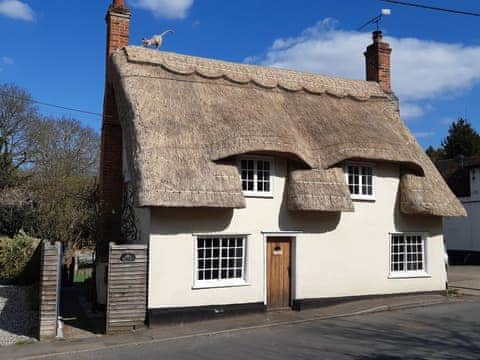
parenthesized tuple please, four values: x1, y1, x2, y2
(346, 164, 375, 199)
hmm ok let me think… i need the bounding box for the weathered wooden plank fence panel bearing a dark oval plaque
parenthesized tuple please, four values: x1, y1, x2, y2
(106, 243, 148, 334)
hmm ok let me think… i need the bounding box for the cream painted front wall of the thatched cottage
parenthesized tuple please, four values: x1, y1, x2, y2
(149, 159, 446, 308)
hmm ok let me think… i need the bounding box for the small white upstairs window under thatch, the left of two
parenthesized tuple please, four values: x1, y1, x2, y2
(239, 158, 272, 196)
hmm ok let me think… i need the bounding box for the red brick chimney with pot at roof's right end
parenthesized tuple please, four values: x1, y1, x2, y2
(364, 30, 392, 93)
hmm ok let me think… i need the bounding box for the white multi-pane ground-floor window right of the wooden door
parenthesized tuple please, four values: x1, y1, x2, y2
(390, 234, 425, 273)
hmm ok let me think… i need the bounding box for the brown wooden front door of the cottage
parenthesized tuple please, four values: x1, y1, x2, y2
(267, 237, 291, 309)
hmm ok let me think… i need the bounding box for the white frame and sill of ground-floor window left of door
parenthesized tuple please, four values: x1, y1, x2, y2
(192, 234, 250, 289)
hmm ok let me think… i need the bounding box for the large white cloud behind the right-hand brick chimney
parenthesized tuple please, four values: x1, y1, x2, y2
(258, 19, 480, 108)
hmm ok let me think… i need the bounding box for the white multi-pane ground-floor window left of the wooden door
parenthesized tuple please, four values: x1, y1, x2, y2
(196, 236, 246, 285)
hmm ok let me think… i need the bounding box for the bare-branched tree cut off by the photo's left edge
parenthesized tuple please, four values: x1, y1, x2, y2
(0, 84, 39, 191)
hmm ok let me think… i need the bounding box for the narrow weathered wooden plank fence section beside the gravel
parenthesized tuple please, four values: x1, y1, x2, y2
(39, 241, 61, 340)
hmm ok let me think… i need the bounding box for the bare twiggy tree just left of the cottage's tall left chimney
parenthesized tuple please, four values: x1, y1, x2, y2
(29, 118, 100, 249)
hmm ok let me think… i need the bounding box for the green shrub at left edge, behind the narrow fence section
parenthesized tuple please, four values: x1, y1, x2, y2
(0, 232, 40, 281)
